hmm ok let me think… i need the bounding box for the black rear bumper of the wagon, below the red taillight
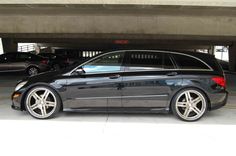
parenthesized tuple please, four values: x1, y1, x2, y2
(210, 91, 228, 110)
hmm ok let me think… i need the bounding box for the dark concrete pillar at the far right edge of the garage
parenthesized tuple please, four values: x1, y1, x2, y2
(229, 42, 236, 72)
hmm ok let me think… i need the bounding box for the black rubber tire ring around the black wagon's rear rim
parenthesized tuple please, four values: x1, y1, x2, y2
(171, 88, 208, 122)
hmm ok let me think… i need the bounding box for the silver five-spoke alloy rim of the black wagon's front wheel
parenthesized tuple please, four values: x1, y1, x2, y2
(26, 87, 57, 119)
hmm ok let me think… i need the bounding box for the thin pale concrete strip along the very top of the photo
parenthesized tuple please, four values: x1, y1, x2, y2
(0, 0, 236, 7)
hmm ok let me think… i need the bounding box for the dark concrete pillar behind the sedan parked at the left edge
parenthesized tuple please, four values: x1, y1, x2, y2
(2, 38, 17, 53)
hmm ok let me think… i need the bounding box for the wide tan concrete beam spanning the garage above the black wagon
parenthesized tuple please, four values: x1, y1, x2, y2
(0, 10, 236, 38)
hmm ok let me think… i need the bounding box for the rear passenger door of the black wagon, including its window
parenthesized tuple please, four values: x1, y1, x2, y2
(122, 51, 181, 108)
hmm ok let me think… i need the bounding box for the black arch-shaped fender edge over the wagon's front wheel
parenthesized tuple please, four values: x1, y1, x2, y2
(21, 83, 63, 110)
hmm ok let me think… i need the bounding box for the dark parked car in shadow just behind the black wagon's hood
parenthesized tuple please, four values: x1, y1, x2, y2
(38, 53, 69, 70)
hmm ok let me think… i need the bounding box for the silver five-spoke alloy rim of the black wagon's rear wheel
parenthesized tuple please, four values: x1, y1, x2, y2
(175, 90, 207, 121)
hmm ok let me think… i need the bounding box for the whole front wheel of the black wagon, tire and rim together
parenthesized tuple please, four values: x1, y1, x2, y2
(25, 86, 61, 119)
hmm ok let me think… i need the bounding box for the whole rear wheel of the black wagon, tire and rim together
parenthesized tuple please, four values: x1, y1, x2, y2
(171, 88, 208, 122)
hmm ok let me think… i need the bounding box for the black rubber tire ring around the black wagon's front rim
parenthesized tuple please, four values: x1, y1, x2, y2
(24, 86, 62, 119)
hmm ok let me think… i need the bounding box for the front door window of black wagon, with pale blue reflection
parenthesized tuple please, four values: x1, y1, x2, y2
(82, 52, 124, 73)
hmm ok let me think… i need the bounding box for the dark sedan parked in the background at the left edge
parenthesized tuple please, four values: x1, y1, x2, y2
(0, 52, 50, 76)
